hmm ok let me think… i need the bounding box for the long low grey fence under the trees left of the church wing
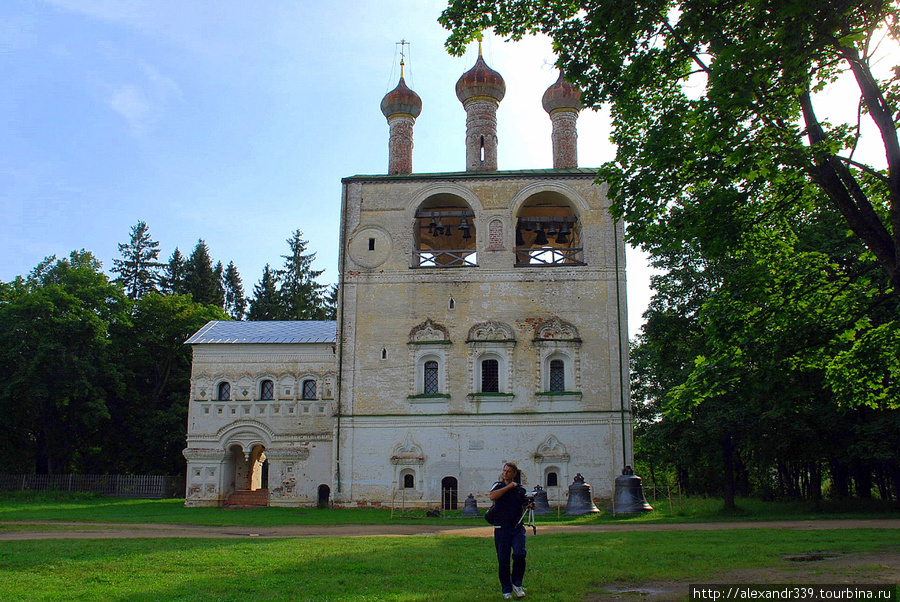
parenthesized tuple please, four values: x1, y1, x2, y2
(0, 474, 184, 499)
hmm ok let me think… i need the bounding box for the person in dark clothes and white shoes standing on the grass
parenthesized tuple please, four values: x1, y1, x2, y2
(488, 462, 529, 599)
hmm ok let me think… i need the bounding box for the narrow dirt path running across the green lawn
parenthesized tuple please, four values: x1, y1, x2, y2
(0, 519, 900, 541)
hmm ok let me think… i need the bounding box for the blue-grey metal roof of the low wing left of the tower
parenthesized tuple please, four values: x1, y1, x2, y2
(185, 320, 337, 345)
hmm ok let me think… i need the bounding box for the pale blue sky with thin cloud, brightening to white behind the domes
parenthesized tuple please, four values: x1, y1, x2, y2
(0, 0, 648, 334)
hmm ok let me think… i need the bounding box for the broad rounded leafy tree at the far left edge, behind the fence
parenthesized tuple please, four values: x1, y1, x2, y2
(0, 250, 130, 474)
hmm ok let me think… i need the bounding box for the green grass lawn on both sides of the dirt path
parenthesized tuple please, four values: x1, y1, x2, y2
(0, 498, 900, 601)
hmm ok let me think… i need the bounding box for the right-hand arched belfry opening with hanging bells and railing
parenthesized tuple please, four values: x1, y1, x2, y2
(516, 191, 584, 266)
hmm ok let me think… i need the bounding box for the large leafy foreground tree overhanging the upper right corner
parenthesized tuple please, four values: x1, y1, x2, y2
(439, 0, 900, 295)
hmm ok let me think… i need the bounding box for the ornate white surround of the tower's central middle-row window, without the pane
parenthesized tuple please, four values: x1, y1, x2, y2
(466, 320, 516, 401)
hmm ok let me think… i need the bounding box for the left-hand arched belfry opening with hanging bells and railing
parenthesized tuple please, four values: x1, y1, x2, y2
(413, 193, 477, 268)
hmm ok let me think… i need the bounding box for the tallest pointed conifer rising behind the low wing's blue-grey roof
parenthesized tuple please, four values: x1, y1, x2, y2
(278, 230, 327, 320)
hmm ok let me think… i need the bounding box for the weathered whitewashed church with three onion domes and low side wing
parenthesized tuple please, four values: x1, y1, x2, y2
(184, 48, 633, 508)
